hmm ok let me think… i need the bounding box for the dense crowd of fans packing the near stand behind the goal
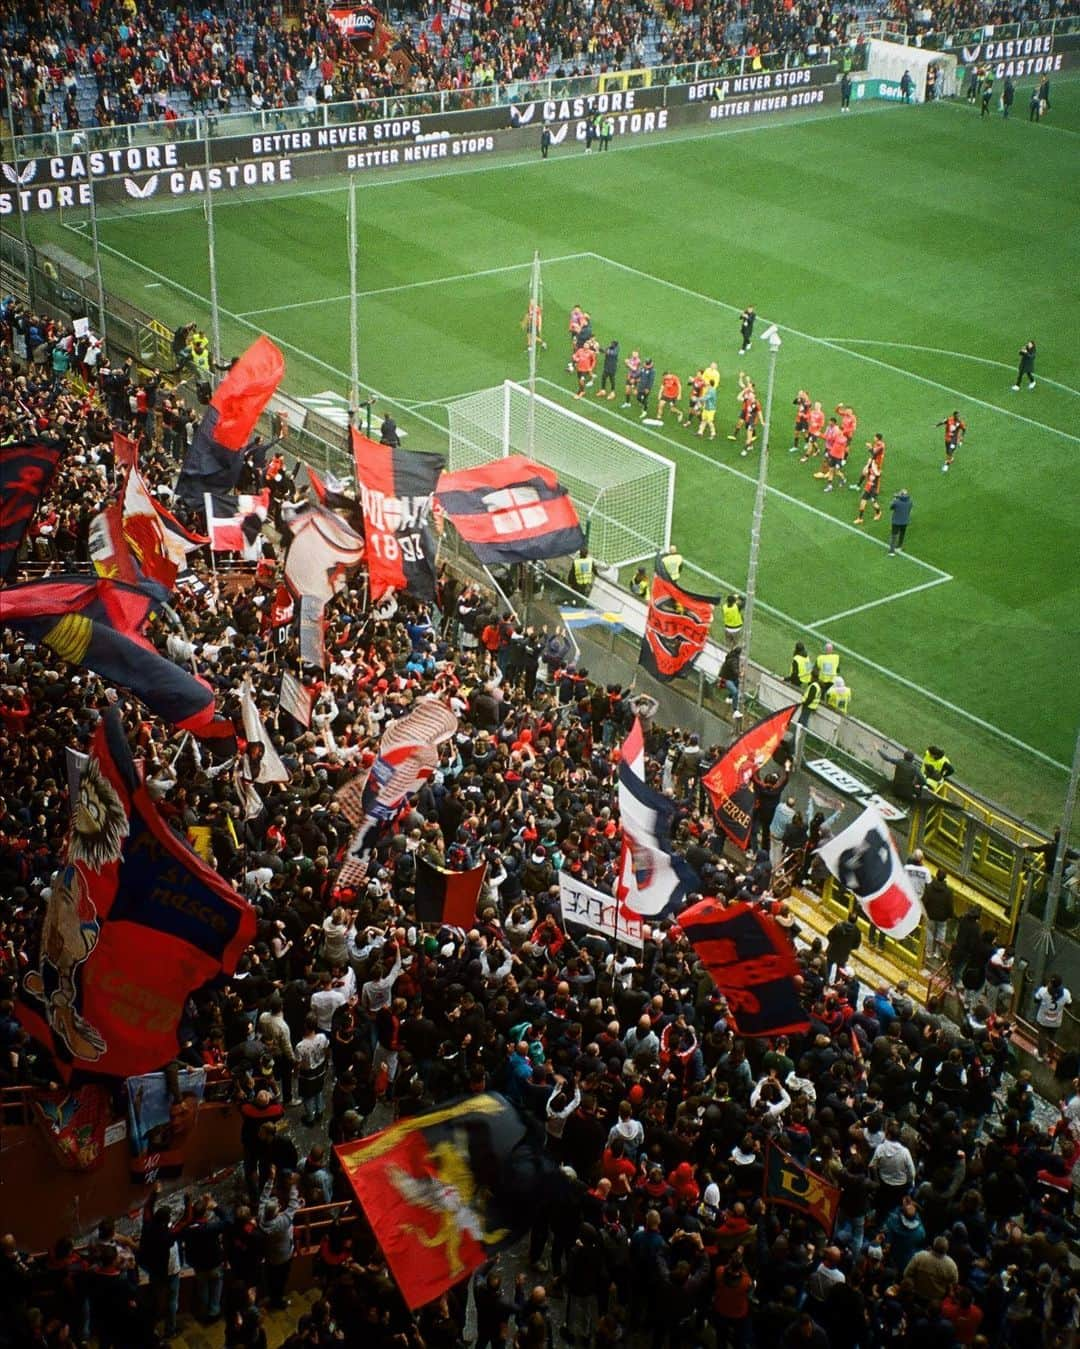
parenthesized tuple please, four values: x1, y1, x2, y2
(0, 302, 1080, 1349)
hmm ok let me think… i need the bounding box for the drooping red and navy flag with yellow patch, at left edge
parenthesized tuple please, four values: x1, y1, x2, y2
(0, 576, 235, 741)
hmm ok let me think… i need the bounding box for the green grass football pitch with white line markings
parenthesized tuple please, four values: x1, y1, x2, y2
(35, 80, 1080, 823)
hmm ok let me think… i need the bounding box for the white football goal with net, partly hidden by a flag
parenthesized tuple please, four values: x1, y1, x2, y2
(448, 380, 676, 567)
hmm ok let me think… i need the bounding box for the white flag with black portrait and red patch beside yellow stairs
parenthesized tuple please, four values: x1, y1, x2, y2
(817, 805, 922, 942)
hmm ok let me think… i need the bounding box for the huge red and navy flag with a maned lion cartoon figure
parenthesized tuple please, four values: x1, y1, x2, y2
(19, 708, 255, 1081)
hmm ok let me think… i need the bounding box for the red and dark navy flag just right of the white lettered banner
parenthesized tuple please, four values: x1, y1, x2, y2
(678, 900, 810, 1035)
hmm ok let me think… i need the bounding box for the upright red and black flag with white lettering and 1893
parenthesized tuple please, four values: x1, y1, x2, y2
(352, 426, 442, 603)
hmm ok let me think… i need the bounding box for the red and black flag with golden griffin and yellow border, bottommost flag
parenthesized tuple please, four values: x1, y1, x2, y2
(334, 1091, 560, 1309)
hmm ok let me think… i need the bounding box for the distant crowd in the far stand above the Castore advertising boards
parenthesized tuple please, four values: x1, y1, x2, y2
(0, 0, 1077, 144)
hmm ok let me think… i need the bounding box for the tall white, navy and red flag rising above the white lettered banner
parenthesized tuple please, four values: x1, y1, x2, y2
(615, 718, 698, 919)
